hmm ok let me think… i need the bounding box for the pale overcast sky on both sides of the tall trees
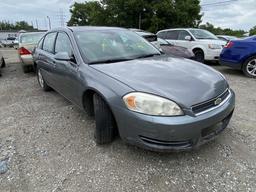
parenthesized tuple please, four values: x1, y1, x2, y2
(0, 0, 256, 30)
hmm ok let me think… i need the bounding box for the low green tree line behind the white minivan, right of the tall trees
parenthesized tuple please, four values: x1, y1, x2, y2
(199, 23, 246, 37)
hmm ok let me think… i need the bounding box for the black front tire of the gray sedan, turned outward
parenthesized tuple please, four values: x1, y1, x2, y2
(93, 94, 114, 144)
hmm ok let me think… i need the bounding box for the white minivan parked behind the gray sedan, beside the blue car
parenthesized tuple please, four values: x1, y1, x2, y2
(157, 28, 226, 63)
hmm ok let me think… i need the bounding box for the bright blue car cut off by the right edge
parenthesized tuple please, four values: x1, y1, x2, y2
(220, 36, 256, 78)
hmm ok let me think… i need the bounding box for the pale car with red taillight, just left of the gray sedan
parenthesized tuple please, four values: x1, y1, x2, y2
(18, 32, 45, 73)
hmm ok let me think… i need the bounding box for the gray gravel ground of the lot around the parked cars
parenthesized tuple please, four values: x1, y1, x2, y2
(0, 50, 256, 192)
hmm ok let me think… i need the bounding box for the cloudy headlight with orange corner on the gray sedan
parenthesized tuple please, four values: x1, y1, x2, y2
(123, 92, 184, 116)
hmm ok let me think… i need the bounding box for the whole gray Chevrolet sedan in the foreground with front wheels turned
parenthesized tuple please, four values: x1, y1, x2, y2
(34, 27, 235, 151)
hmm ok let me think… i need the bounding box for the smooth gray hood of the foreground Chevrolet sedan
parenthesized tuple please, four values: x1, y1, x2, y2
(91, 56, 228, 108)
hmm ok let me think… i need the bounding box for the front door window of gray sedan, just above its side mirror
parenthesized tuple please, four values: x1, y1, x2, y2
(55, 33, 72, 56)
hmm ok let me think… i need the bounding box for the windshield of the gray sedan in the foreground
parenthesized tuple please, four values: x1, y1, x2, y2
(74, 30, 161, 64)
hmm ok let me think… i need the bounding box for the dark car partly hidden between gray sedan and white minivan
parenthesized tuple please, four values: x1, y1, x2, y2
(157, 38, 195, 59)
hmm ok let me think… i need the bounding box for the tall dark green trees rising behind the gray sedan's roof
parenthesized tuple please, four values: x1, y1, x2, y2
(68, 0, 202, 32)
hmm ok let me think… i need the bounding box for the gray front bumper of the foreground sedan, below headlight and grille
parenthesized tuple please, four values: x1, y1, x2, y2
(113, 91, 235, 151)
